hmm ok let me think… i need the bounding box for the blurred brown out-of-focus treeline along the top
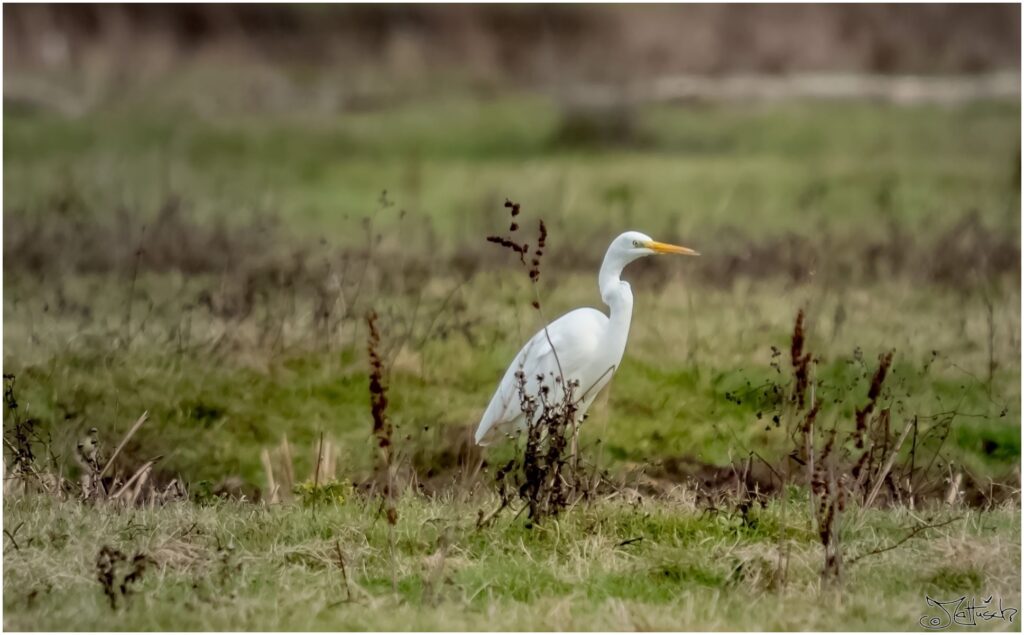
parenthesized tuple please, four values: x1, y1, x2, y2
(3, 4, 1020, 83)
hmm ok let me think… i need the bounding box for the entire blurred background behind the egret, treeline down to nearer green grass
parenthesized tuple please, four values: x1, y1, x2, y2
(3, 4, 1021, 501)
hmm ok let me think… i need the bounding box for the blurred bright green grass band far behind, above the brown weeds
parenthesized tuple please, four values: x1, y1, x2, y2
(4, 96, 1020, 242)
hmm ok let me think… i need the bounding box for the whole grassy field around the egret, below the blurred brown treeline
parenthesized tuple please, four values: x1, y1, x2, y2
(3, 71, 1021, 630)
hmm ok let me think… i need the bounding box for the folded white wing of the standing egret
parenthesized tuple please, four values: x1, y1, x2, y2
(476, 308, 608, 445)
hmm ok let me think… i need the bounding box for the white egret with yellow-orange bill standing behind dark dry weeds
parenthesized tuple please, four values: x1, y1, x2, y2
(476, 231, 699, 446)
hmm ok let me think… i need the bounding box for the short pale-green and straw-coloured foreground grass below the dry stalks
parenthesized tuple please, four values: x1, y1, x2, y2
(4, 499, 1020, 630)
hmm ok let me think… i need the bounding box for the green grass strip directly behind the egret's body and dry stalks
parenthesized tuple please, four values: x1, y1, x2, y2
(5, 277, 1020, 485)
